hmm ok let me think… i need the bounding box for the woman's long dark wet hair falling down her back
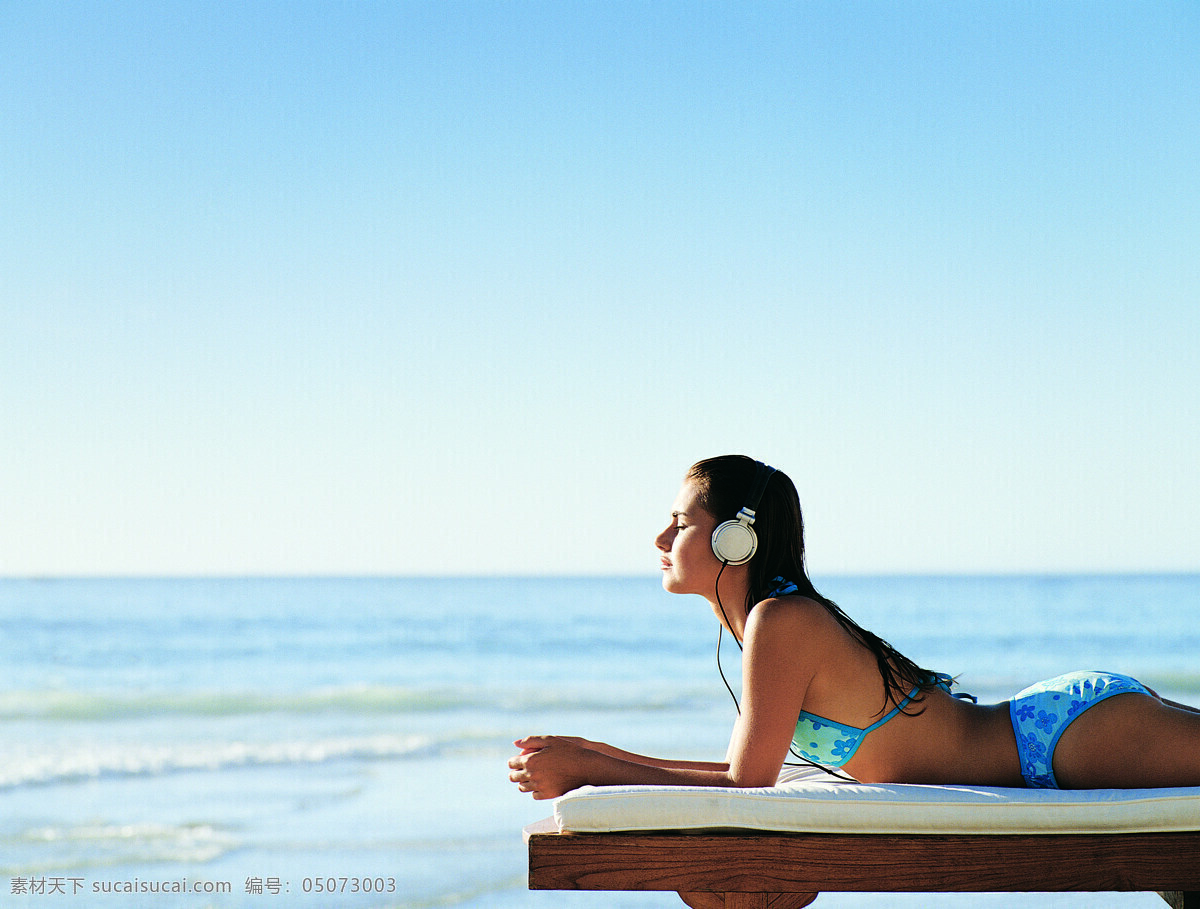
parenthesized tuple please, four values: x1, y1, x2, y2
(684, 455, 938, 714)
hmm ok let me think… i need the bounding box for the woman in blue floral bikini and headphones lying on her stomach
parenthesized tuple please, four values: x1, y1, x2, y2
(509, 456, 1200, 799)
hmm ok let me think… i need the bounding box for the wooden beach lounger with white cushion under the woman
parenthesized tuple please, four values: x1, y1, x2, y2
(526, 771, 1200, 909)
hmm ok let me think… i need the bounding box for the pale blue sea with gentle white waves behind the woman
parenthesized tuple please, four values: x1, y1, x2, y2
(0, 576, 1200, 909)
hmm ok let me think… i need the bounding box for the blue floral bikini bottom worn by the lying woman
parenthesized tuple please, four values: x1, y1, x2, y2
(1008, 672, 1150, 789)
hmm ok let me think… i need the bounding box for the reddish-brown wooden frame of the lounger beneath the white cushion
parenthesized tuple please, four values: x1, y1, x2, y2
(524, 819, 1200, 909)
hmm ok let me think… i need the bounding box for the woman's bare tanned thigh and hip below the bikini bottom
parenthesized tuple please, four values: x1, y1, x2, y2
(1054, 693, 1200, 789)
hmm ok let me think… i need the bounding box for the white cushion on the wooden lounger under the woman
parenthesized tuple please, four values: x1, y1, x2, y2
(554, 770, 1200, 833)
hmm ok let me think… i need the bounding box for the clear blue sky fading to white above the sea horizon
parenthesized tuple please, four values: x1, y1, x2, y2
(0, 0, 1200, 577)
